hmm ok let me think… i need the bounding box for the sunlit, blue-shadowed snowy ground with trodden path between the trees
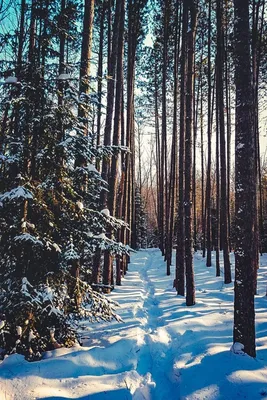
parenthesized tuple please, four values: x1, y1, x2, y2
(0, 249, 267, 400)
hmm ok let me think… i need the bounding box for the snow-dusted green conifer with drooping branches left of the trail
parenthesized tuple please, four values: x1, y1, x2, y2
(0, 0, 128, 360)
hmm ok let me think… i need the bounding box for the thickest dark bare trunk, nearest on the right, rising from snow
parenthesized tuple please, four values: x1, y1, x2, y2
(233, 0, 257, 357)
